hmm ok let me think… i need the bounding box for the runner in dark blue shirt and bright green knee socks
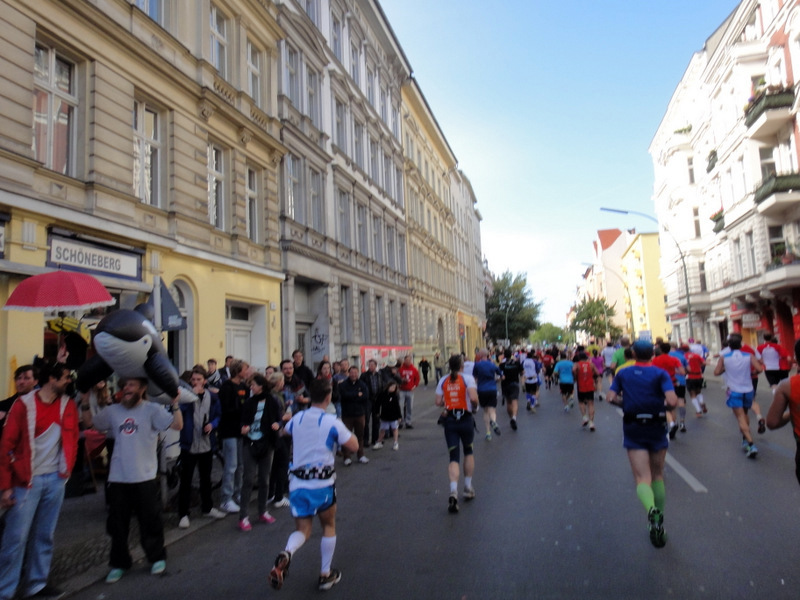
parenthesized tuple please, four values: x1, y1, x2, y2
(606, 340, 678, 548)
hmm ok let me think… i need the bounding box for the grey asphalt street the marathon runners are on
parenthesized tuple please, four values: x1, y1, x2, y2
(67, 378, 800, 600)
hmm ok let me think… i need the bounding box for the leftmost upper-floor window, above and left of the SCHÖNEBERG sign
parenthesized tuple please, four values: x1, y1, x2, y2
(33, 44, 78, 175)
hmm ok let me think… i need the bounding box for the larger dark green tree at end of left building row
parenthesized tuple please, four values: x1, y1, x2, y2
(486, 271, 542, 344)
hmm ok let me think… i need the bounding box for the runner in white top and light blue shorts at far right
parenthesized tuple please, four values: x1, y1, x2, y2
(714, 333, 761, 458)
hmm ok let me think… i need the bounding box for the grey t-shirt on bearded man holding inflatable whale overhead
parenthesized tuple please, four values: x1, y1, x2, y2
(92, 400, 172, 483)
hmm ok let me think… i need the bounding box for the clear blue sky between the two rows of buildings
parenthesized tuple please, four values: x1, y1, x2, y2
(379, 0, 739, 326)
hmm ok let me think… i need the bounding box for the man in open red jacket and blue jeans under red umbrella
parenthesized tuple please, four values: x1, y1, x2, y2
(0, 363, 78, 600)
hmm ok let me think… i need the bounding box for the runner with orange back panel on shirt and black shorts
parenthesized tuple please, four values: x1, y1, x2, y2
(436, 355, 478, 513)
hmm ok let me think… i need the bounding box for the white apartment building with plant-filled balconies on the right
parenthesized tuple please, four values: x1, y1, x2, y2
(650, 0, 800, 349)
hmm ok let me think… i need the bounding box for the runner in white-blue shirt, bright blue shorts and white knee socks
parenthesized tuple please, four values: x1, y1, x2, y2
(269, 379, 358, 590)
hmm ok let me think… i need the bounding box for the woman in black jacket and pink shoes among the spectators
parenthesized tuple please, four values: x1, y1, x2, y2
(239, 373, 283, 531)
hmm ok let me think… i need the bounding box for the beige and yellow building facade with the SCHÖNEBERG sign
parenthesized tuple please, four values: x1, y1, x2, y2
(0, 0, 286, 387)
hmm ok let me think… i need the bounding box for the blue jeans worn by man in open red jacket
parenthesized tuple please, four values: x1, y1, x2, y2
(0, 473, 67, 600)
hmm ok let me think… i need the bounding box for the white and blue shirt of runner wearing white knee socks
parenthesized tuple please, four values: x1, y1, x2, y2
(285, 406, 353, 492)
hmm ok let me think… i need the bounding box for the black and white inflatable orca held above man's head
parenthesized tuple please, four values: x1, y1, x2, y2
(76, 304, 197, 404)
